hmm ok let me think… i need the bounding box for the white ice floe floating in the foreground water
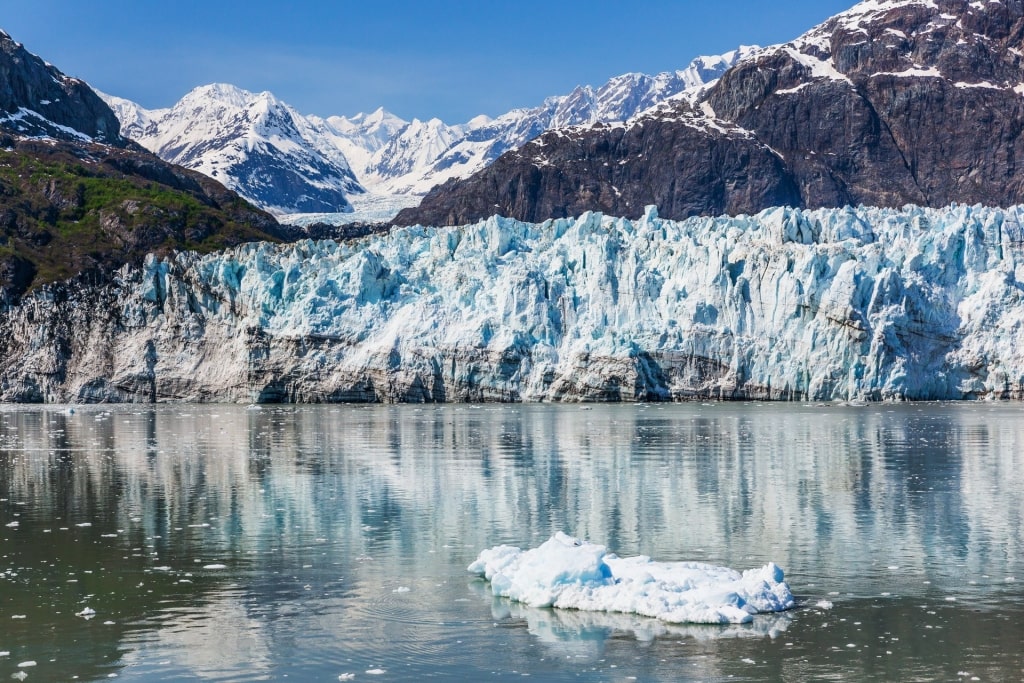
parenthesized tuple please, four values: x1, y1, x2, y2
(469, 532, 794, 624)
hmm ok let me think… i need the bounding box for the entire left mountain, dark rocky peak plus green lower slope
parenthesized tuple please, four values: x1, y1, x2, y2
(0, 32, 287, 305)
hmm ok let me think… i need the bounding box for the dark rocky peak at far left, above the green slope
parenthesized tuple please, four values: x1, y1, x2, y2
(0, 31, 127, 145)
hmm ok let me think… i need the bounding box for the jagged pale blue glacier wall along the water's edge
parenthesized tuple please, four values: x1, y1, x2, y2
(0, 205, 1024, 402)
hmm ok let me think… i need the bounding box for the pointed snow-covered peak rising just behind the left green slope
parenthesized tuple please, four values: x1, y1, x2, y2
(104, 84, 366, 213)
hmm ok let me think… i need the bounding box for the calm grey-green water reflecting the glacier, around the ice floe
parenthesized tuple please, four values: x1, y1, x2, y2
(0, 403, 1024, 682)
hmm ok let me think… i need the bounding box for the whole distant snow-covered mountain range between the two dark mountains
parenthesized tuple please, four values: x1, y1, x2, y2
(102, 47, 756, 214)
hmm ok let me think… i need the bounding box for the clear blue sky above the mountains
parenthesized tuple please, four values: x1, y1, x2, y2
(8, 0, 854, 123)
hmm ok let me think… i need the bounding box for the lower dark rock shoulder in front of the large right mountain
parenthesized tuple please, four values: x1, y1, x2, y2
(403, 102, 800, 225)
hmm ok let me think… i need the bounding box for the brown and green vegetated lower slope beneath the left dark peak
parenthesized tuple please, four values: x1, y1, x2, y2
(0, 136, 282, 300)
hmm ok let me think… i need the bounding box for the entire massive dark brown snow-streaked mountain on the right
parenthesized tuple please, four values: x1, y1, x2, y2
(395, 0, 1024, 224)
